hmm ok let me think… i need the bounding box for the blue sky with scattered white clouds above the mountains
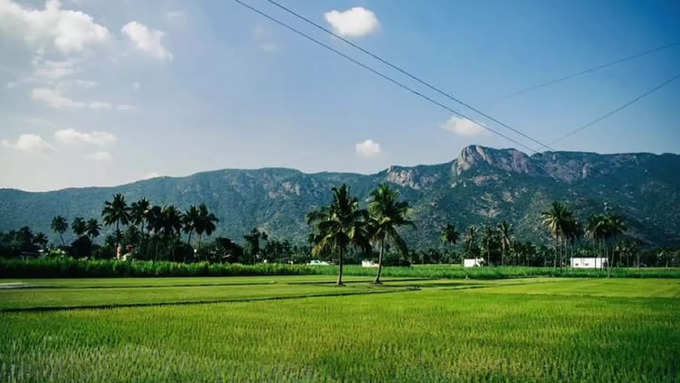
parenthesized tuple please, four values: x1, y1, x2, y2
(0, 0, 680, 190)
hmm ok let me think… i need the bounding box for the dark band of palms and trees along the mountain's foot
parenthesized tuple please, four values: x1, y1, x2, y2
(0, 184, 680, 283)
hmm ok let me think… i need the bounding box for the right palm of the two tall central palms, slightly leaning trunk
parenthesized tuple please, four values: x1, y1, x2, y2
(368, 184, 415, 284)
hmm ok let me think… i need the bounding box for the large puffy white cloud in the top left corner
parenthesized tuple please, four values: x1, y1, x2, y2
(0, 0, 110, 53)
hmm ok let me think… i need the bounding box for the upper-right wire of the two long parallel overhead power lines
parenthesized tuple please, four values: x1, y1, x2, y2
(267, 0, 554, 150)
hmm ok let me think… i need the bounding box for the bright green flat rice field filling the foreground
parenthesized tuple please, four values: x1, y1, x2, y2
(0, 276, 680, 382)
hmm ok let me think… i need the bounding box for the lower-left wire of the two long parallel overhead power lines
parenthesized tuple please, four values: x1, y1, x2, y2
(234, 0, 538, 153)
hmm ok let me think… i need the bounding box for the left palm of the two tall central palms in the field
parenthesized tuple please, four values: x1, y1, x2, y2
(307, 184, 370, 286)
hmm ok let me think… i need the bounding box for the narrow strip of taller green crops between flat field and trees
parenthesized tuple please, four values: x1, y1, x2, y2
(0, 258, 680, 279)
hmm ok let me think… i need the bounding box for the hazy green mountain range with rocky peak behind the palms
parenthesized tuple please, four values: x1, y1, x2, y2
(0, 145, 680, 247)
